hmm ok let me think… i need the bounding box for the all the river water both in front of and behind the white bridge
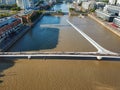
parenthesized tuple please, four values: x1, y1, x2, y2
(0, 3, 120, 90)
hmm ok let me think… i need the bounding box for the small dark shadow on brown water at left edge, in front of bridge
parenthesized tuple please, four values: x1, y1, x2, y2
(0, 58, 14, 83)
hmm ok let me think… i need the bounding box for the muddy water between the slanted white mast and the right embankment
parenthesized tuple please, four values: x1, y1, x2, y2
(69, 17, 120, 53)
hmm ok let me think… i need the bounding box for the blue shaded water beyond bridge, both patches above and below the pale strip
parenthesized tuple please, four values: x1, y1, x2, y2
(8, 16, 60, 52)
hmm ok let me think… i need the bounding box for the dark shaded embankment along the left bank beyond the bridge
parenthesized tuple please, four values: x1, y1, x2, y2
(0, 14, 44, 51)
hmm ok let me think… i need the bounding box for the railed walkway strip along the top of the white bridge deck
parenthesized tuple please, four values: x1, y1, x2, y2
(0, 52, 120, 56)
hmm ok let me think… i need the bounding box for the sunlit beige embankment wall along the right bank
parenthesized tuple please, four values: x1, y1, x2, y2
(88, 14, 120, 37)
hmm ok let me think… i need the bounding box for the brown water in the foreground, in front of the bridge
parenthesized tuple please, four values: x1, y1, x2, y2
(0, 59, 120, 90)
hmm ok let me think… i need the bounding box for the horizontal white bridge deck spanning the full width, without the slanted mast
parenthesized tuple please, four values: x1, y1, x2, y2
(0, 52, 120, 60)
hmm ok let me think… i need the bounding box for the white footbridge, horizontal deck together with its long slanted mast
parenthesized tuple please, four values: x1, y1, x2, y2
(0, 20, 120, 60)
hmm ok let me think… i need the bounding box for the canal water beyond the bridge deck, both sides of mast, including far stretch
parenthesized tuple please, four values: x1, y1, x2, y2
(8, 4, 120, 52)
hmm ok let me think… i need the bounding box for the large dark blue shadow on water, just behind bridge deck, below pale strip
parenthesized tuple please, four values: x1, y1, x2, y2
(8, 27, 59, 52)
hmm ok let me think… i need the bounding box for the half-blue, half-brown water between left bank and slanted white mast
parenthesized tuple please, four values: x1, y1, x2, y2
(8, 15, 97, 52)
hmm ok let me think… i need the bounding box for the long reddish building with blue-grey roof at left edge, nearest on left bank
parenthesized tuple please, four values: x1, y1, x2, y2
(0, 17, 22, 38)
